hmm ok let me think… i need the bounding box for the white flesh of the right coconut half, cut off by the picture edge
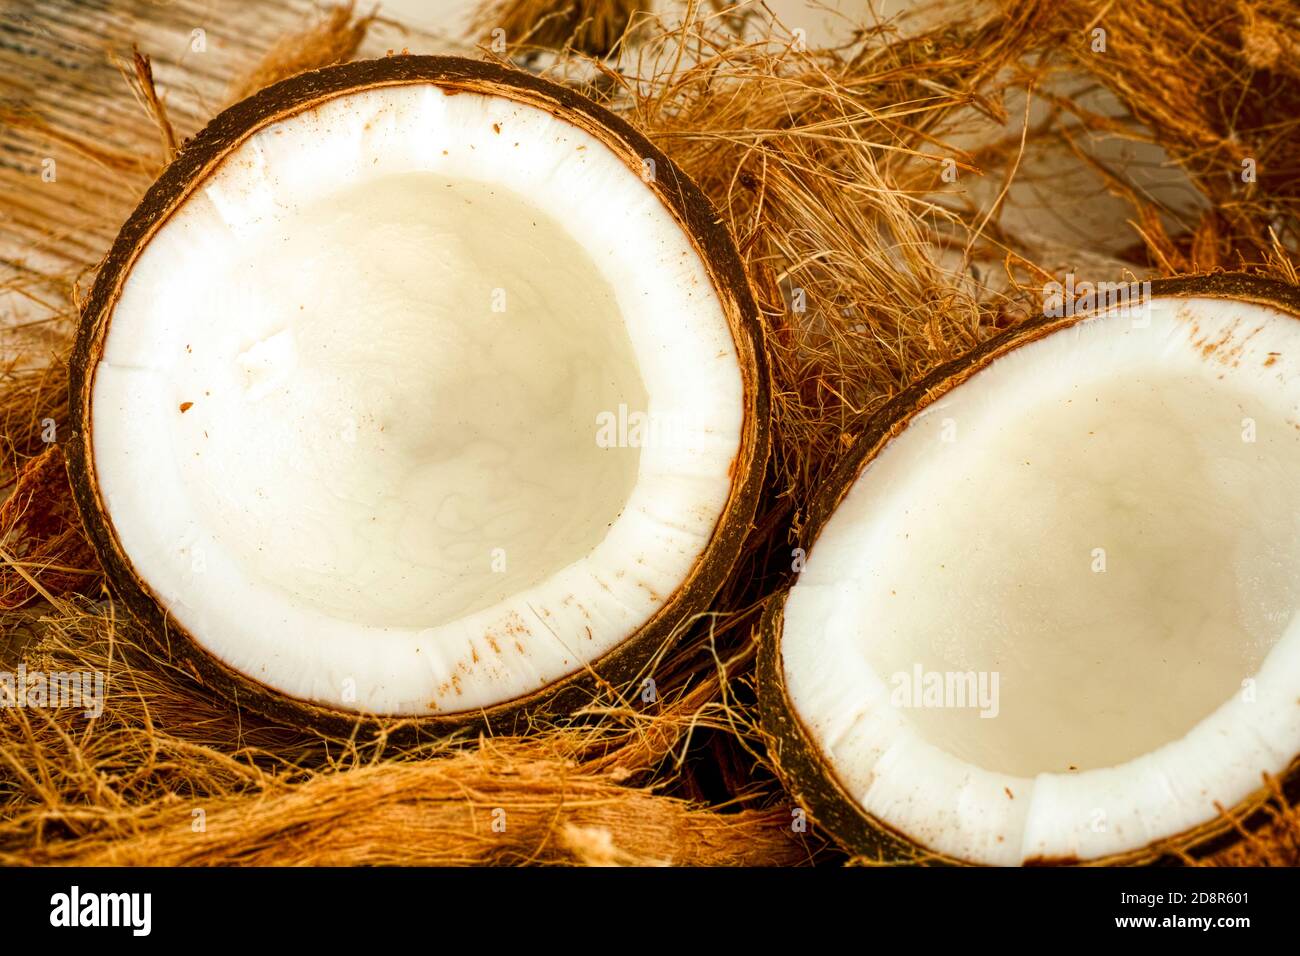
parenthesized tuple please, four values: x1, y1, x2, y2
(781, 298, 1300, 864)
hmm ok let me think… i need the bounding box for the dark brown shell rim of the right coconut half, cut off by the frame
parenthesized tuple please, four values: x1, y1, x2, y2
(757, 273, 1300, 866)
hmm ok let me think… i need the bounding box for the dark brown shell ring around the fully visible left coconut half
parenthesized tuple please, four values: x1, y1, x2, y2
(65, 55, 770, 735)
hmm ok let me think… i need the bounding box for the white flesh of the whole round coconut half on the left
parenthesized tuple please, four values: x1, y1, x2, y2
(92, 85, 744, 715)
